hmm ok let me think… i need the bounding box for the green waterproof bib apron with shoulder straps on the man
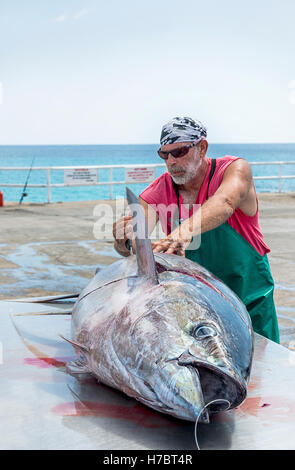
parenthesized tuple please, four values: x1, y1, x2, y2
(172, 159, 280, 343)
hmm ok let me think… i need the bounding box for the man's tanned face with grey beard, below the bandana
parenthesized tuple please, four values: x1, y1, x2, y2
(161, 142, 202, 184)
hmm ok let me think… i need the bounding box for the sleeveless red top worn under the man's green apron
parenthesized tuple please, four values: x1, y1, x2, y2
(140, 155, 270, 256)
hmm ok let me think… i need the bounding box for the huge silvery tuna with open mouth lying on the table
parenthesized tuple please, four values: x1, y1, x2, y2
(68, 190, 253, 422)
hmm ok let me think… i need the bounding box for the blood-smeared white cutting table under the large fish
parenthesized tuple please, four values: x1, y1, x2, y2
(0, 301, 295, 451)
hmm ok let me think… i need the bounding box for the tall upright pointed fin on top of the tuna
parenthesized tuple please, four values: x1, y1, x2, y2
(126, 188, 159, 284)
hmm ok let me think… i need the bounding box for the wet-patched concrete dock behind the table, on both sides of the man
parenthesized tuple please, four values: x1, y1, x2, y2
(0, 193, 295, 350)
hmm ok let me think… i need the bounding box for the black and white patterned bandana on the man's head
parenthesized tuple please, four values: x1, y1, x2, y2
(160, 117, 207, 146)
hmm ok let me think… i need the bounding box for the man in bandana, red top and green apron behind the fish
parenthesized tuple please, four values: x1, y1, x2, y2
(114, 117, 279, 343)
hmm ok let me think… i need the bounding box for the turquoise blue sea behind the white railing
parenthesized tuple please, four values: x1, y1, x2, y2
(0, 143, 295, 203)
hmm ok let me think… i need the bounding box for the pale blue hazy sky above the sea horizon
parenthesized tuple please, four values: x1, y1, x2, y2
(0, 0, 295, 145)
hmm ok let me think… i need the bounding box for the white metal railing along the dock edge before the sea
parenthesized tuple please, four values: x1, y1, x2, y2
(0, 161, 295, 203)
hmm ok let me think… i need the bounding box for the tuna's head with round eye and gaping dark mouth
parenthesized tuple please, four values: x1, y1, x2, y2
(126, 273, 253, 422)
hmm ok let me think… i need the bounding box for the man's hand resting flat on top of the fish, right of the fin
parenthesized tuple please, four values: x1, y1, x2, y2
(152, 219, 193, 256)
